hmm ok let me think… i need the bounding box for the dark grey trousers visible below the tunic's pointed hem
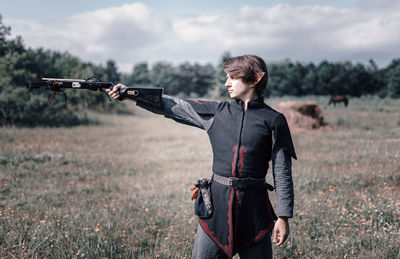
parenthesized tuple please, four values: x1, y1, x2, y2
(192, 225, 272, 259)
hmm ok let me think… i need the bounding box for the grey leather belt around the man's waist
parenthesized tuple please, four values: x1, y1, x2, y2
(211, 173, 274, 191)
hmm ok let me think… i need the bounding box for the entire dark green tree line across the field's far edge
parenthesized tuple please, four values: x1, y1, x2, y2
(0, 15, 400, 126)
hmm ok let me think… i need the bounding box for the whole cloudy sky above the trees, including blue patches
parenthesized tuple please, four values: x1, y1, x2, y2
(0, 0, 400, 71)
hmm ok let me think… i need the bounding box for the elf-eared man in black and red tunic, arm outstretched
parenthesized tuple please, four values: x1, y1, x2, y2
(107, 55, 296, 259)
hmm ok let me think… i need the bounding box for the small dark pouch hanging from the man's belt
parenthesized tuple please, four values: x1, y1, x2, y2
(192, 178, 213, 219)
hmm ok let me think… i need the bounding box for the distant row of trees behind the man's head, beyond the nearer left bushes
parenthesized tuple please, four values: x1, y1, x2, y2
(122, 53, 400, 99)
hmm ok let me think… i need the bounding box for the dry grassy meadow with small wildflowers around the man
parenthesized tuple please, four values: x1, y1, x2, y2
(0, 97, 400, 258)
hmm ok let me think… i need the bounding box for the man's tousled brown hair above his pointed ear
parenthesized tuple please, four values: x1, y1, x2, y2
(224, 55, 268, 96)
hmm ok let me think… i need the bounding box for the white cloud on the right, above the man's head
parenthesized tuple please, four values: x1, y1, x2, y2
(171, 2, 400, 66)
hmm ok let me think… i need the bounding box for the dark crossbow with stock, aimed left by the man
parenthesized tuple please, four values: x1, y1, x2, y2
(26, 76, 163, 106)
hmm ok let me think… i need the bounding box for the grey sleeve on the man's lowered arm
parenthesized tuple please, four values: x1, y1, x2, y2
(272, 147, 294, 218)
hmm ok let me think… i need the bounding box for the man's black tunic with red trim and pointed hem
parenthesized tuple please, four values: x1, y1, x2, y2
(138, 95, 296, 257)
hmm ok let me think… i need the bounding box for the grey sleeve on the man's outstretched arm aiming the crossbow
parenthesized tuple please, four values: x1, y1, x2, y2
(137, 95, 214, 130)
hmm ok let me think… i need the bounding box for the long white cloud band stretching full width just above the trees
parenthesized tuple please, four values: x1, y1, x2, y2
(5, 0, 400, 71)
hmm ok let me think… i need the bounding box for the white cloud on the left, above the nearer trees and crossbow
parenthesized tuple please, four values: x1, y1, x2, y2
(5, 3, 173, 70)
